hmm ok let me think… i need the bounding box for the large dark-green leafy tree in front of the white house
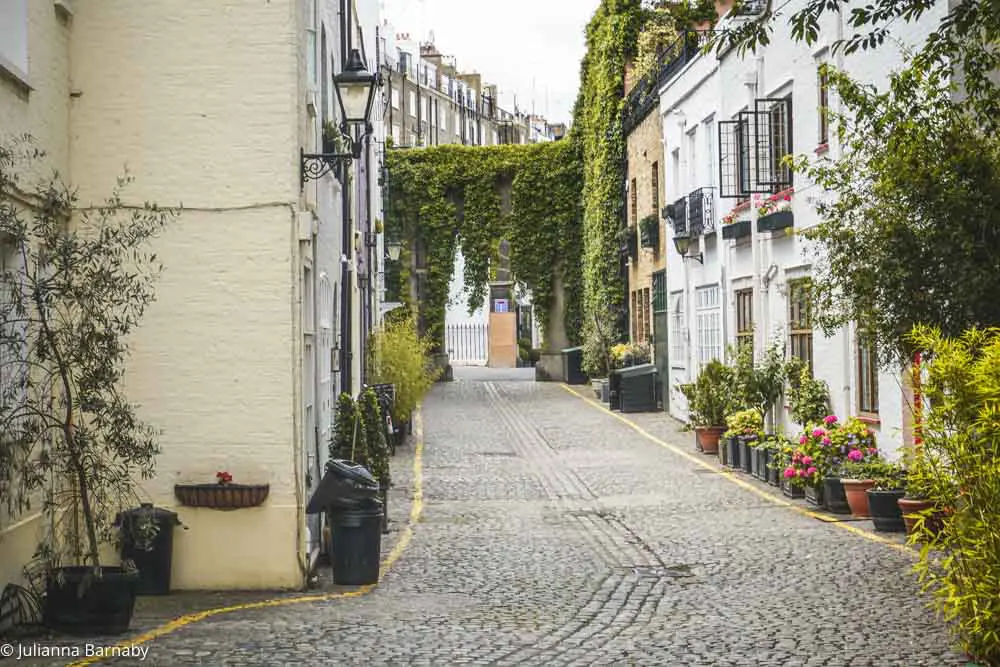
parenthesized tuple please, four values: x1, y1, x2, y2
(796, 68, 1000, 362)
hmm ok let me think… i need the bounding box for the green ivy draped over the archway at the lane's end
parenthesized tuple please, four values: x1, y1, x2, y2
(386, 140, 583, 349)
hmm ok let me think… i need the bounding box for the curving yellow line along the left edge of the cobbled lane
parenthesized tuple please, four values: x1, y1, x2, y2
(67, 410, 424, 667)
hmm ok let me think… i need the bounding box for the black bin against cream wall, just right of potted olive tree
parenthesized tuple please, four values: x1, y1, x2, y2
(118, 503, 181, 595)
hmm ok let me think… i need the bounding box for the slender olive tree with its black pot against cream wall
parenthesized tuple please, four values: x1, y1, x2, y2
(0, 140, 175, 634)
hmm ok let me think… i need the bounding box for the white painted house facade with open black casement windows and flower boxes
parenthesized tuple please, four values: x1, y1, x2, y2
(660, 0, 947, 455)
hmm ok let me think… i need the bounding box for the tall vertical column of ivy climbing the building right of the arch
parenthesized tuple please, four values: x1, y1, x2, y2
(570, 0, 644, 374)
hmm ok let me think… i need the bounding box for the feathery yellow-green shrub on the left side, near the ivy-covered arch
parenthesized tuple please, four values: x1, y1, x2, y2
(372, 314, 441, 423)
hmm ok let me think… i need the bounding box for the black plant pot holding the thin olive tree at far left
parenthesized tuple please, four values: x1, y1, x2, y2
(43, 566, 139, 635)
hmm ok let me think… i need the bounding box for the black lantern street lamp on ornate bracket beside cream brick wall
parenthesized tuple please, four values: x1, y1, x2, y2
(299, 49, 381, 185)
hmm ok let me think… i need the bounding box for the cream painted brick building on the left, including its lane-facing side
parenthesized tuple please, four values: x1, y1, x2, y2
(0, 0, 384, 589)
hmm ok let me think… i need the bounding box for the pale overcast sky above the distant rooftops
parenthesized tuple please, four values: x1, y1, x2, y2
(382, 0, 600, 123)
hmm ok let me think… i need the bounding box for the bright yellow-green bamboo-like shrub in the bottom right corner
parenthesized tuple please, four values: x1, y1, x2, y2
(909, 326, 1000, 665)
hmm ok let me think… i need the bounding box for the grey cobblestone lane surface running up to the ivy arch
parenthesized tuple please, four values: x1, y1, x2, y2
(15, 369, 964, 667)
